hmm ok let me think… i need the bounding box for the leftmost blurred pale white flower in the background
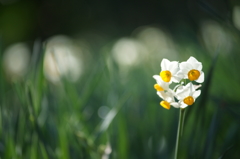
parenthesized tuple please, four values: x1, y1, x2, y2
(3, 43, 30, 80)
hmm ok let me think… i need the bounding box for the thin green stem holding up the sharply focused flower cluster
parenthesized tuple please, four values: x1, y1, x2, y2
(174, 108, 185, 159)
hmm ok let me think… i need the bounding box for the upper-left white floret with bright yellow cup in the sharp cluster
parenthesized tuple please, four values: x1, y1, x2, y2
(160, 59, 181, 83)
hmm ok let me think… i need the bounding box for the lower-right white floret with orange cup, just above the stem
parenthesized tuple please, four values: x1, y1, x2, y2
(176, 82, 201, 108)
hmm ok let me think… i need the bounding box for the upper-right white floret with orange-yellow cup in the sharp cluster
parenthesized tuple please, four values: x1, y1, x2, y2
(178, 56, 204, 83)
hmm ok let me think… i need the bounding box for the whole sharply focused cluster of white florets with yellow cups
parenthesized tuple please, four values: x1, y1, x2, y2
(153, 57, 204, 109)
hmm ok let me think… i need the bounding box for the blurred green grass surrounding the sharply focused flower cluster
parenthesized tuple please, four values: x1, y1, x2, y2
(0, 26, 240, 159)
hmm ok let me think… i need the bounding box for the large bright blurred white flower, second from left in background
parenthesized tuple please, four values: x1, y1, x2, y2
(44, 36, 83, 83)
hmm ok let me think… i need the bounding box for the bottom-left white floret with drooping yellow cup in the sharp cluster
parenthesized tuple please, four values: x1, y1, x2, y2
(157, 89, 179, 109)
